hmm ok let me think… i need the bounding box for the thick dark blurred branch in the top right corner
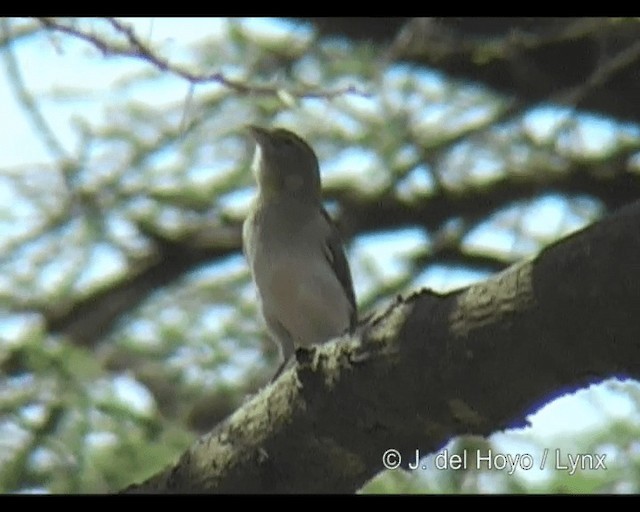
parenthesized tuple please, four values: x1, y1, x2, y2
(297, 18, 640, 122)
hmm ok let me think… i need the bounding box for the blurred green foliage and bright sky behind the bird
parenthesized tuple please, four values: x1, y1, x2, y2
(0, 19, 640, 493)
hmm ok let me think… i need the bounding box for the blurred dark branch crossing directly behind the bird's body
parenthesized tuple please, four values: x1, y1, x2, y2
(31, 147, 640, 345)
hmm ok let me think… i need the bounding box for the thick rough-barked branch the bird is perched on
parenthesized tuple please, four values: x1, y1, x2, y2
(128, 202, 640, 492)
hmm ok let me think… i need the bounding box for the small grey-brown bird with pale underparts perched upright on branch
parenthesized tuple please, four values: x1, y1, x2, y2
(242, 125, 357, 381)
